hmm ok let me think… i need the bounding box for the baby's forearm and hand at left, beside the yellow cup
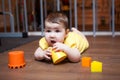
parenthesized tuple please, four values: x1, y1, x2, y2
(34, 47, 51, 60)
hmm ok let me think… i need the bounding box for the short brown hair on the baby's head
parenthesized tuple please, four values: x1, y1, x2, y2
(45, 12, 68, 29)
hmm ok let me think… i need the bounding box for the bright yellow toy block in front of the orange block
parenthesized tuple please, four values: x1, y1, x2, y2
(91, 61, 102, 72)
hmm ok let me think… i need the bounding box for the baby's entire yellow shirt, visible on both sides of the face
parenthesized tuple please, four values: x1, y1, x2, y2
(39, 32, 89, 53)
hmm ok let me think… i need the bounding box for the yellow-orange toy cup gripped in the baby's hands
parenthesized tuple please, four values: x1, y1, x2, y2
(51, 47, 67, 64)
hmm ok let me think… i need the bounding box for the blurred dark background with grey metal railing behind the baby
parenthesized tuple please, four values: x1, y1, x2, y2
(0, 0, 120, 50)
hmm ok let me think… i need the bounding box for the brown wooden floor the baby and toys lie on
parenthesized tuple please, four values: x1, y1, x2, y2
(0, 36, 120, 80)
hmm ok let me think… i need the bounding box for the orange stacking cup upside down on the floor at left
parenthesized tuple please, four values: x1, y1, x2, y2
(8, 51, 25, 69)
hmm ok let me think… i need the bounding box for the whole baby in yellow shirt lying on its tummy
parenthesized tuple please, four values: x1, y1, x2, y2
(34, 12, 89, 62)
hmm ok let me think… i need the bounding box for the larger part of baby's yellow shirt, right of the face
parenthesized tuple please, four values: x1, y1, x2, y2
(64, 32, 89, 53)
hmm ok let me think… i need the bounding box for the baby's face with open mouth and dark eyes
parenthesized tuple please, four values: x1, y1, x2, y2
(45, 22, 66, 46)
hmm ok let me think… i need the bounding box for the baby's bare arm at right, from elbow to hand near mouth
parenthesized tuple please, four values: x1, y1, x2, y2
(53, 42, 80, 62)
